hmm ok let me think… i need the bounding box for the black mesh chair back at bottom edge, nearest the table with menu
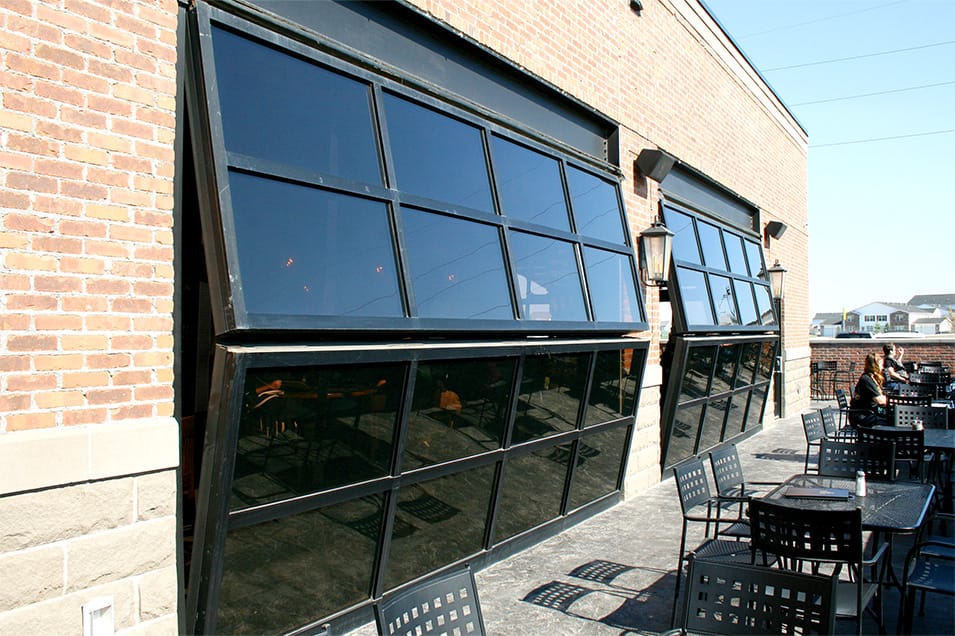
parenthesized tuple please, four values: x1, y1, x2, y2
(683, 559, 837, 636)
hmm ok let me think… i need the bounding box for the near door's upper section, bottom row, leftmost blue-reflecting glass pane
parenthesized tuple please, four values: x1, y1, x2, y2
(229, 172, 404, 317)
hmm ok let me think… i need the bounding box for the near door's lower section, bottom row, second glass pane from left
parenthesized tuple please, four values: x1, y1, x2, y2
(385, 464, 495, 588)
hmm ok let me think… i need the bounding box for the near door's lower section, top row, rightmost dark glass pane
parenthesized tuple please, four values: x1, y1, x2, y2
(584, 349, 644, 426)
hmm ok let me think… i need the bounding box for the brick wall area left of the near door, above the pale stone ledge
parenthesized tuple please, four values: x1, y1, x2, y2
(0, 0, 177, 432)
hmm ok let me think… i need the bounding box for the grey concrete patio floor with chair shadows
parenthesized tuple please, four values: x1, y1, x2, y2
(352, 403, 955, 636)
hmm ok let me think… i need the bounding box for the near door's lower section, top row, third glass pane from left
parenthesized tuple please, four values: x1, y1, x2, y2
(511, 353, 590, 444)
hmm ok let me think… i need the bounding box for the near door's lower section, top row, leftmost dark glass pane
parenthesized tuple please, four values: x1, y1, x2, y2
(232, 364, 405, 510)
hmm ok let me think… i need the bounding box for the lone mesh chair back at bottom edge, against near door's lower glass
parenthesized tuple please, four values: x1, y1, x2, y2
(375, 568, 485, 636)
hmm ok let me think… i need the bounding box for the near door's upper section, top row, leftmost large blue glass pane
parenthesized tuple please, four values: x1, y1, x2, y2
(212, 28, 381, 185)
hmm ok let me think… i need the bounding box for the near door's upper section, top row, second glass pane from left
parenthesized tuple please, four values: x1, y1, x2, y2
(384, 93, 494, 212)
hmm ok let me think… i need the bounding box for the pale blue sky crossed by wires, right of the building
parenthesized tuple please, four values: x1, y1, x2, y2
(703, 0, 955, 315)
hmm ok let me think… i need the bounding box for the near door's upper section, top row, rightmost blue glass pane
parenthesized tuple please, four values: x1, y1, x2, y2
(567, 166, 626, 243)
